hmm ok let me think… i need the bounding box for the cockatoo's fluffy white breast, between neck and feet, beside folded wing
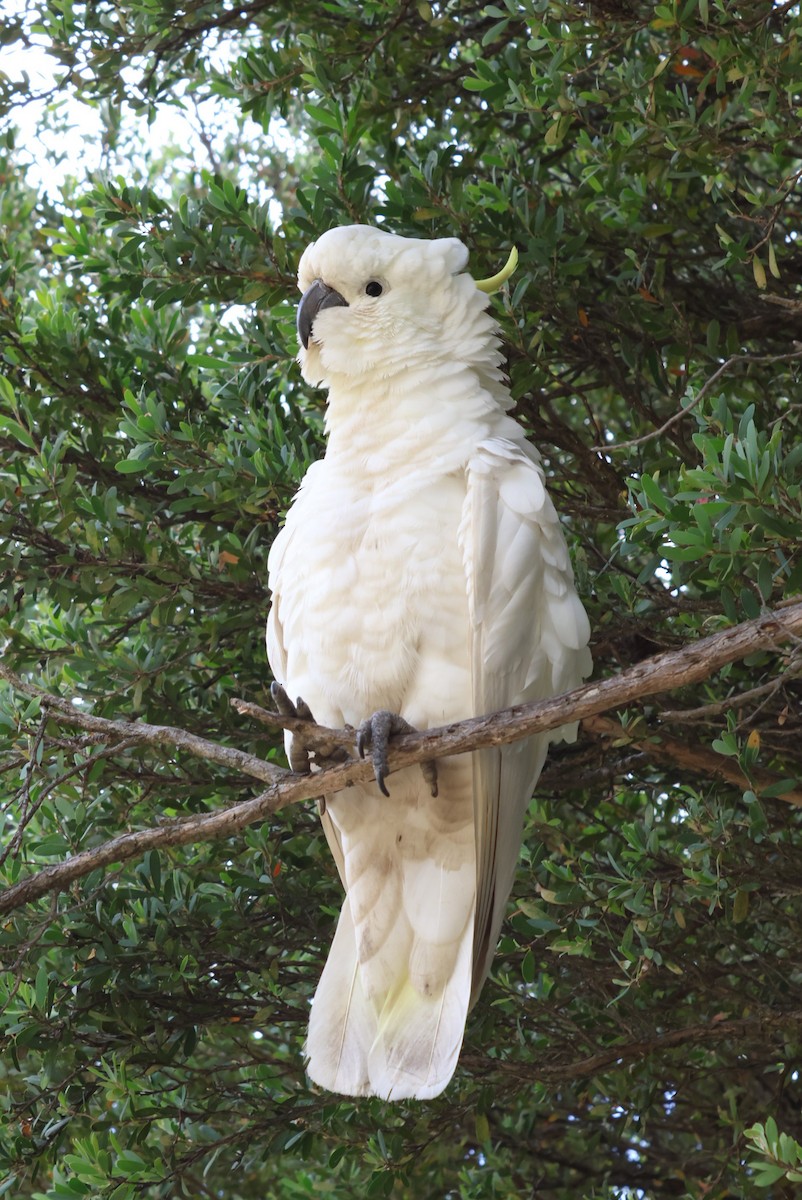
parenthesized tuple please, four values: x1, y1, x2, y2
(270, 461, 471, 726)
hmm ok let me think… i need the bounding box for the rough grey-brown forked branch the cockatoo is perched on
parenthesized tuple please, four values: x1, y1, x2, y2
(0, 600, 802, 913)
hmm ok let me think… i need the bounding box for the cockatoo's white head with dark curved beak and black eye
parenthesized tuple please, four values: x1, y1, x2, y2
(298, 226, 495, 384)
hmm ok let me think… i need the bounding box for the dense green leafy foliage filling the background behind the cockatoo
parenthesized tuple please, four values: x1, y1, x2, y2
(0, 0, 802, 1200)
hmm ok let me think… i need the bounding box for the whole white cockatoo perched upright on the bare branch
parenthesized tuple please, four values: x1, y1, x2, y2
(268, 226, 589, 1099)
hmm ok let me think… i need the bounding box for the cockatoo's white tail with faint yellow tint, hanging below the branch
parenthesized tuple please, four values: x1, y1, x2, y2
(306, 760, 475, 1099)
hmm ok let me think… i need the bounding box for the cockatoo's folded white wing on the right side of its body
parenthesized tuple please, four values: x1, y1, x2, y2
(460, 438, 591, 1000)
